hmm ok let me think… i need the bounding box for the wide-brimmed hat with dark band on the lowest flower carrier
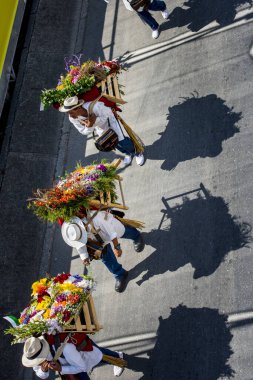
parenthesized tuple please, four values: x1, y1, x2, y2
(22, 336, 50, 367)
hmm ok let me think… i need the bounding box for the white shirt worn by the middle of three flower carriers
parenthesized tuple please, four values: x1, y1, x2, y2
(77, 211, 125, 260)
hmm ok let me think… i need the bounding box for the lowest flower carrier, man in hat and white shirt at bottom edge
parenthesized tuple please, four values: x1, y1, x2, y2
(22, 333, 127, 380)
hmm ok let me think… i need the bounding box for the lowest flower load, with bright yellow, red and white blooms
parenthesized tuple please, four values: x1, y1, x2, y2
(5, 273, 96, 344)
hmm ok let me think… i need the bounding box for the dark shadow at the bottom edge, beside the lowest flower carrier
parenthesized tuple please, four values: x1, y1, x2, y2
(126, 305, 234, 380)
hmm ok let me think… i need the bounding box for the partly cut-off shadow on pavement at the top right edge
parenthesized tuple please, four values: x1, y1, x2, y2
(161, 0, 252, 32)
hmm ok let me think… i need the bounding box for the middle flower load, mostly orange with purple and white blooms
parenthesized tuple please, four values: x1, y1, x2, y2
(28, 160, 117, 223)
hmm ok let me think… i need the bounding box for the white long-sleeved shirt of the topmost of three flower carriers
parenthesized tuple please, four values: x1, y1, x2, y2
(69, 102, 124, 141)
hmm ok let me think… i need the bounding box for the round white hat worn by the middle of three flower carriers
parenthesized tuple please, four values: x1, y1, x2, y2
(61, 217, 88, 249)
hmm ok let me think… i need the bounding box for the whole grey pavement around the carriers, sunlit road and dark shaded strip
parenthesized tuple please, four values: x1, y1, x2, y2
(0, 0, 253, 380)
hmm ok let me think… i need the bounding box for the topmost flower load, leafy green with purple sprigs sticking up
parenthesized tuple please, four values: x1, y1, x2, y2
(41, 55, 121, 108)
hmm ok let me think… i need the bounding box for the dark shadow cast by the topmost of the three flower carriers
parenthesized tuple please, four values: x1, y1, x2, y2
(145, 93, 241, 170)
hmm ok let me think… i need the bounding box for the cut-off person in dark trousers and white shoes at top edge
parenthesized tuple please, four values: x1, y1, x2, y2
(123, 0, 169, 39)
